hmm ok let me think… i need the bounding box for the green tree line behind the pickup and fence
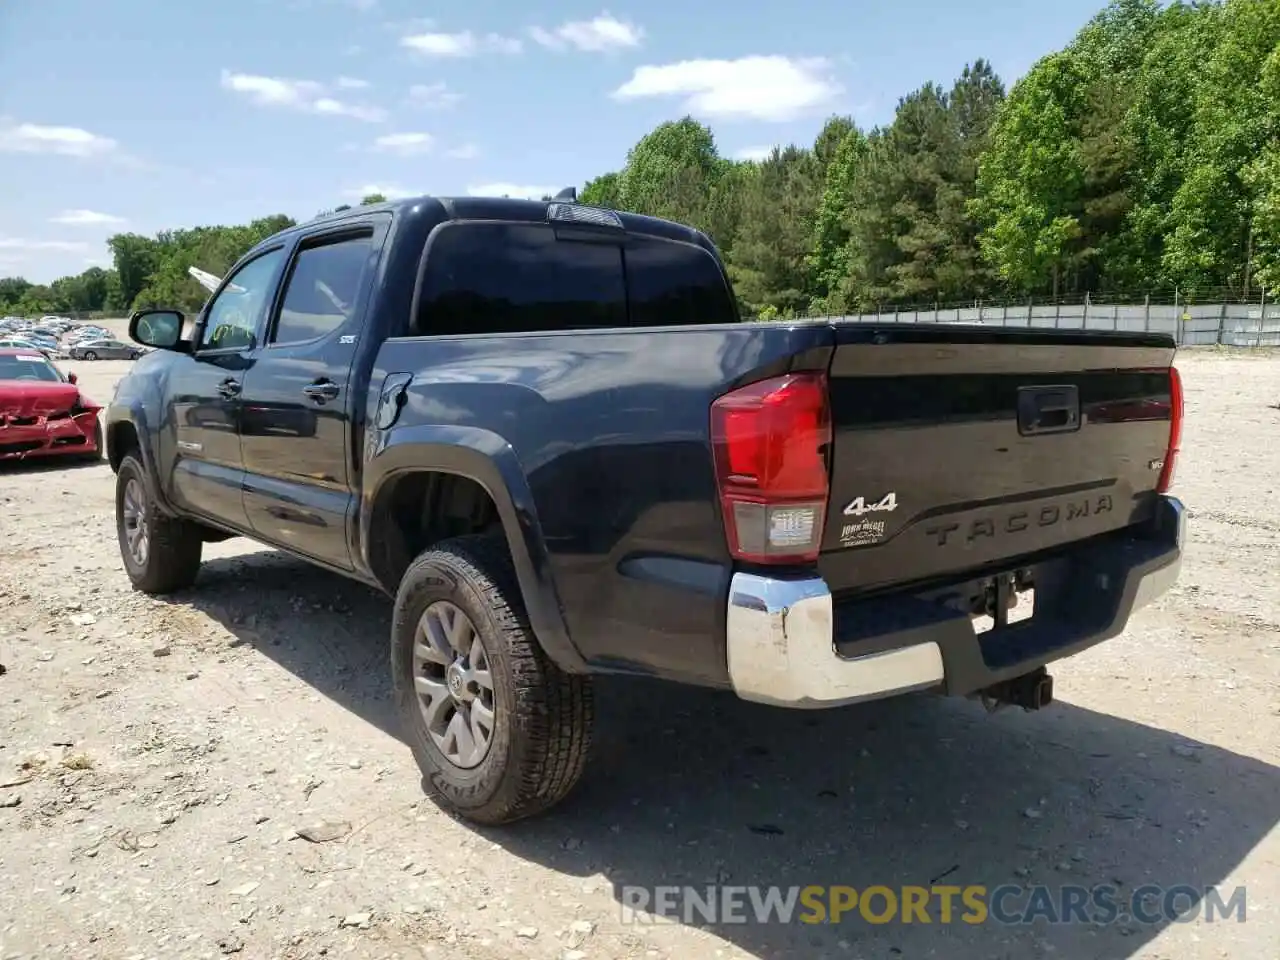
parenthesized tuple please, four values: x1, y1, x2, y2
(0, 0, 1280, 323)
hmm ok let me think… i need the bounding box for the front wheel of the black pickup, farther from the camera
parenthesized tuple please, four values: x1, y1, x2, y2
(115, 453, 204, 594)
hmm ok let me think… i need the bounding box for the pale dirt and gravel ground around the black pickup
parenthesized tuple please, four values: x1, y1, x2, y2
(0, 355, 1280, 960)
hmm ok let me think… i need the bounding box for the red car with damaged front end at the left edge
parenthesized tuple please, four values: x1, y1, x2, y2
(0, 347, 102, 463)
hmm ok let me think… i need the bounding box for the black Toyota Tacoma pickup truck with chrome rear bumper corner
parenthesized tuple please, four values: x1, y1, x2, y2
(106, 197, 1184, 823)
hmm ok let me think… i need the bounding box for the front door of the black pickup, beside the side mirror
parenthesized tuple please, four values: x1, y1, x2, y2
(168, 247, 284, 532)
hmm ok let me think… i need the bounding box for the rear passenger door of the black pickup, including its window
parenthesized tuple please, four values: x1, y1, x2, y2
(241, 216, 388, 570)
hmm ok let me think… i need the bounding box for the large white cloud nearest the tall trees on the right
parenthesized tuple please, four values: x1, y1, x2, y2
(613, 56, 842, 122)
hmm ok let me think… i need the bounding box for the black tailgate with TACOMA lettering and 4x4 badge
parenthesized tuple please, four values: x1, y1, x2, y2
(819, 324, 1174, 593)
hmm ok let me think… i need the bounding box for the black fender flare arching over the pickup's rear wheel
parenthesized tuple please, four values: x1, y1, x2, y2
(360, 425, 586, 673)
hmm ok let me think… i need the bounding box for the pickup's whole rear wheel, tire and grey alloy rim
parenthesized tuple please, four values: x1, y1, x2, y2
(392, 535, 594, 824)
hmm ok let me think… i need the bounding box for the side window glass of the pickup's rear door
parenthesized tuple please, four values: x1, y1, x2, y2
(271, 232, 374, 343)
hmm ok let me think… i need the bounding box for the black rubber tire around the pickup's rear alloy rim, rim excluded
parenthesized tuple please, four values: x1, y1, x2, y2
(392, 534, 595, 824)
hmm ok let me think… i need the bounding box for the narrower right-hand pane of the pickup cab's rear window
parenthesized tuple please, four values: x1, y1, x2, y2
(626, 238, 741, 326)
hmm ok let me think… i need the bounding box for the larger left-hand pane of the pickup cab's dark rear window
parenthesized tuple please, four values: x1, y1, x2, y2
(417, 223, 627, 335)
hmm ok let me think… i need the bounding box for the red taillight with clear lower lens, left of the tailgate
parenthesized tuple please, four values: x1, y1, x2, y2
(710, 372, 831, 563)
